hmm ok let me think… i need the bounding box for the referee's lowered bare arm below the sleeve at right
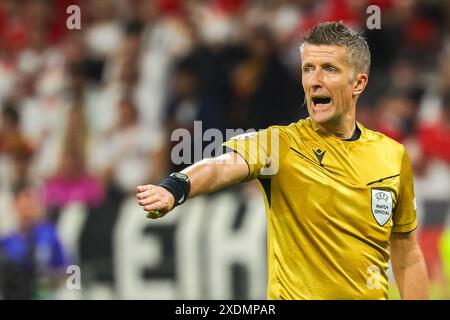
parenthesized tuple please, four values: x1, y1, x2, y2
(390, 231, 429, 300)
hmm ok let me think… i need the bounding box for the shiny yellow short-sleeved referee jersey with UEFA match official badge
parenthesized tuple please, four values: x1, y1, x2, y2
(224, 118, 417, 299)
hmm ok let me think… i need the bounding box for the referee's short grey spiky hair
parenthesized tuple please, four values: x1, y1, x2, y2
(300, 21, 370, 75)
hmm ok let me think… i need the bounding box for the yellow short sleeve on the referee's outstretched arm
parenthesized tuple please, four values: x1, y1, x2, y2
(223, 126, 290, 181)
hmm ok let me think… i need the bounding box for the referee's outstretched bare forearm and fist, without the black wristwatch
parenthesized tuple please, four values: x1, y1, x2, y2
(136, 152, 249, 218)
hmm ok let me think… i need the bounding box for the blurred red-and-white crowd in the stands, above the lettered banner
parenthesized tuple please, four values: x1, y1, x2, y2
(0, 0, 450, 298)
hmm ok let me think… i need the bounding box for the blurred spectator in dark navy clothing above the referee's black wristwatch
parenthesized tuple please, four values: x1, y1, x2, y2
(164, 39, 245, 170)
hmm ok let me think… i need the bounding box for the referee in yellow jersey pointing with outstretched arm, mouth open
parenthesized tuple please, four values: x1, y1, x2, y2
(137, 22, 428, 299)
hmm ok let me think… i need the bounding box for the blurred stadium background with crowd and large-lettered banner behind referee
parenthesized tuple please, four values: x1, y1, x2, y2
(0, 0, 450, 299)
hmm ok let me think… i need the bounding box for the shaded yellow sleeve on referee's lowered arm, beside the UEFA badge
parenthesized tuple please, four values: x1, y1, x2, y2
(392, 148, 417, 233)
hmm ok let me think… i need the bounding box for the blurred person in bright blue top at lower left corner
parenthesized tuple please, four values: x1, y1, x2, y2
(0, 183, 68, 299)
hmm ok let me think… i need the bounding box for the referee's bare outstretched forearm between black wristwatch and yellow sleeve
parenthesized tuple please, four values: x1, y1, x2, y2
(182, 154, 248, 198)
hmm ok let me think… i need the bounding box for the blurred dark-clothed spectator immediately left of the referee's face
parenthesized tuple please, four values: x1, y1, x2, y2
(230, 26, 303, 130)
